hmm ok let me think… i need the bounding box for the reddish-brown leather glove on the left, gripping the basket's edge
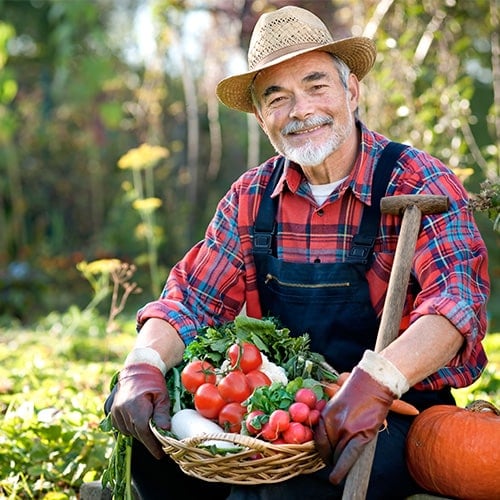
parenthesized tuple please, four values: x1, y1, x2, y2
(110, 363, 170, 459)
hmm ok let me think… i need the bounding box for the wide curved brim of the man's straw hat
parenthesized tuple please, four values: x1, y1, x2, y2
(216, 37, 377, 113)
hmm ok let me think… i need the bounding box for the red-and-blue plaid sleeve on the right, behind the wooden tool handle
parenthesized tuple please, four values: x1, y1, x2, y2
(374, 145, 489, 389)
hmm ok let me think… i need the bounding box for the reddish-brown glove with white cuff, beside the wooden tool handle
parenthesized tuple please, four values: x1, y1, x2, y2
(314, 351, 409, 485)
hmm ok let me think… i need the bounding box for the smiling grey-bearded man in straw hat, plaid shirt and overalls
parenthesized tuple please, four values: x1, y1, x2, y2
(108, 7, 489, 500)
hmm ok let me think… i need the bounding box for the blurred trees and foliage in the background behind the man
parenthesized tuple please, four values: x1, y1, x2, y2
(0, 0, 500, 329)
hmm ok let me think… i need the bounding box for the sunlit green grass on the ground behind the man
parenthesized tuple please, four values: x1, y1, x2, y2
(0, 308, 500, 500)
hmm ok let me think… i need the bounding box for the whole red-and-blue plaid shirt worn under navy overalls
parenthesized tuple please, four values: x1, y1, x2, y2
(138, 124, 489, 389)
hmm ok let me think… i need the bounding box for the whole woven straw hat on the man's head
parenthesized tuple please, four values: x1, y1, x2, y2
(216, 6, 376, 113)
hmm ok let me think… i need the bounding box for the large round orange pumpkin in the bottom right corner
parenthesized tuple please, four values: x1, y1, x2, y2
(406, 401, 500, 500)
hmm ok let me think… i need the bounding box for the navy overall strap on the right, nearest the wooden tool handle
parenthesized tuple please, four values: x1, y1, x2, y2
(346, 142, 408, 265)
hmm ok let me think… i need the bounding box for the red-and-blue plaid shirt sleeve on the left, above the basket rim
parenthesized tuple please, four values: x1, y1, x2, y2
(137, 164, 274, 344)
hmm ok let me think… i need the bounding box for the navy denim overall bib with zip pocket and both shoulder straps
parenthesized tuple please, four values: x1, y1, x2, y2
(253, 143, 403, 372)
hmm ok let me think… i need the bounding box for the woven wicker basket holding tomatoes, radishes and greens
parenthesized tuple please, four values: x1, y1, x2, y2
(150, 423, 325, 485)
